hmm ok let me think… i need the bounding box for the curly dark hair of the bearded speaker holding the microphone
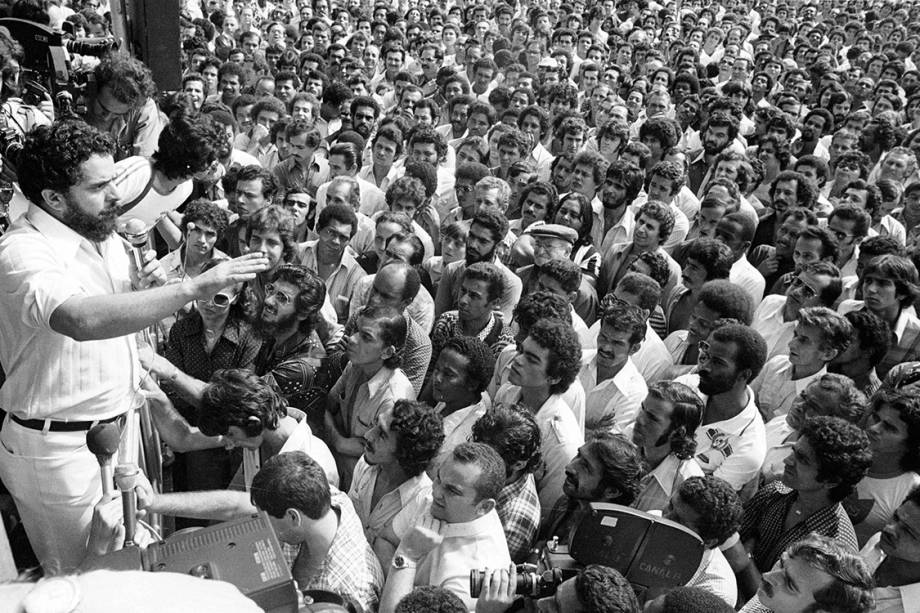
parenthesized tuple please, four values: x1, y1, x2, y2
(18, 121, 115, 205)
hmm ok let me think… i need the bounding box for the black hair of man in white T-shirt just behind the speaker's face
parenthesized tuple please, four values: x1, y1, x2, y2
(153, 111, 224, 179)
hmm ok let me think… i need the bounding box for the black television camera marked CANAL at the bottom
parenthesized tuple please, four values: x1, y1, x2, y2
(470, 503, 705, 602)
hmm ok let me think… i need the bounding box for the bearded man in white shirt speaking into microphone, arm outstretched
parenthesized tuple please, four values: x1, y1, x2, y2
(0, 122, 268, 571)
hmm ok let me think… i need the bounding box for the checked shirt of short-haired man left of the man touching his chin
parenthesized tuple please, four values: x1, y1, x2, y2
(282, 488, 385, 611)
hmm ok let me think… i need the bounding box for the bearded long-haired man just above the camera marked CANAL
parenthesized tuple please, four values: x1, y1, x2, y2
(540, 432, 642, 541)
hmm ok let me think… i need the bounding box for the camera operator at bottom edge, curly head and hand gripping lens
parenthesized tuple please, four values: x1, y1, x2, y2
(476, 564, 640, 613)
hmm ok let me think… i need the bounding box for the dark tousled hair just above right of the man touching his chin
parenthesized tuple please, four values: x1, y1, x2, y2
(472, 405, 543, 478)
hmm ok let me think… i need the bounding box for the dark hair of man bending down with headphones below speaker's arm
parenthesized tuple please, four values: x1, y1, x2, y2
(198, 368, 287, 436)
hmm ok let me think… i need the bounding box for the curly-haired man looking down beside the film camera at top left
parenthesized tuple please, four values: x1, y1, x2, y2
(85, 52, 166, 160)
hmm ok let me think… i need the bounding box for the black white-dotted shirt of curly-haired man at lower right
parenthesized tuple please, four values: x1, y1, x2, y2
(738, 481, 859, 573)
